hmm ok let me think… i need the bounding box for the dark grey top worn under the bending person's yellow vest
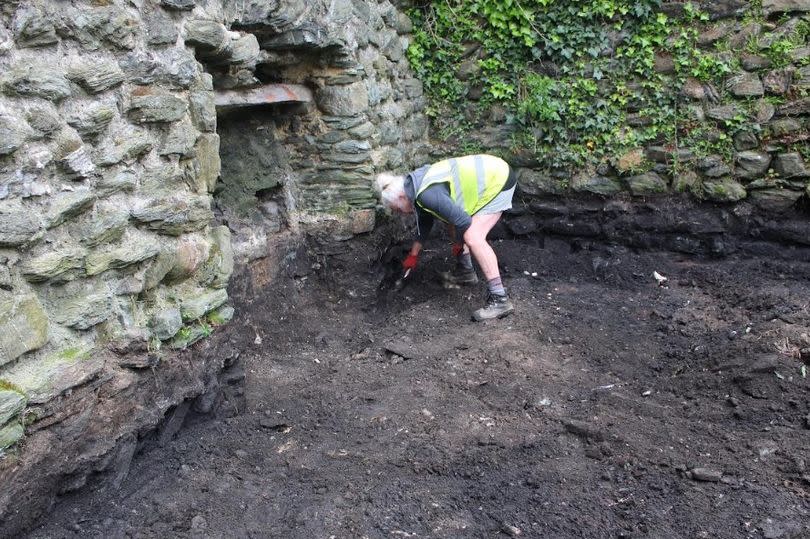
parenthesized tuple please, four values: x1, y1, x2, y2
(405, 165, 472, 243)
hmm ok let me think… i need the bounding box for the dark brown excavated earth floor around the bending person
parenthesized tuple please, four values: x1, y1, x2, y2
(22, 230, 810, 538)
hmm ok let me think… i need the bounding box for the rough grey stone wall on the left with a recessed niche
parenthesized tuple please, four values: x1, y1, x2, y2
(0, 0, 427, 535)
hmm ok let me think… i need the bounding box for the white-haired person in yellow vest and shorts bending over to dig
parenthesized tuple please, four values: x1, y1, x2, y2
(376, 154, 517, 321)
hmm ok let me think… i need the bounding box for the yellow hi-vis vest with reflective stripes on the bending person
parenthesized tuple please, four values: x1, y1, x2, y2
(416, 155, 509, 219)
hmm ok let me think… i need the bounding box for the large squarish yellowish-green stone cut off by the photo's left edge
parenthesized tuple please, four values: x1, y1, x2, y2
(0, 295, 48, 365)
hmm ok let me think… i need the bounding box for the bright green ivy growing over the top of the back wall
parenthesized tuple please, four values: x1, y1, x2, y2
(408, 0, 734, 168)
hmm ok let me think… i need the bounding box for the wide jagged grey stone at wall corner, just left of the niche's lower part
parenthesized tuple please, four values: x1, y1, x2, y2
(132, 195, 213, 236)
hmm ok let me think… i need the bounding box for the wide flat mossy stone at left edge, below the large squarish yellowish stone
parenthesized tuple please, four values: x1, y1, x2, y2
(4, 346, 104, 404)
